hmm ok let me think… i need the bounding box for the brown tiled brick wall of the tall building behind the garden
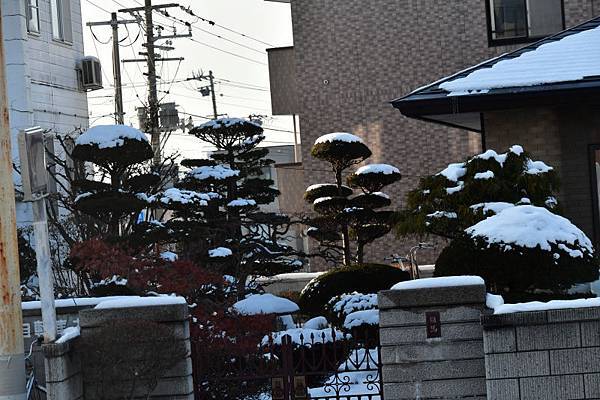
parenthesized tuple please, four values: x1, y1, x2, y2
(291, 0, 593, 268)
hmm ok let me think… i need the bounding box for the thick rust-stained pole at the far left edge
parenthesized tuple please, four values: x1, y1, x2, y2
(0, 5, 27, 400)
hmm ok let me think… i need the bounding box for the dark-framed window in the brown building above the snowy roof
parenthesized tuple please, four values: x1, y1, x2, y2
(487, 0, 564, 45)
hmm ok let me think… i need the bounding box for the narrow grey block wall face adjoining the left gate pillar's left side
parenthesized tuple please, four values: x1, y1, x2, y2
(42, 339, 83, 400)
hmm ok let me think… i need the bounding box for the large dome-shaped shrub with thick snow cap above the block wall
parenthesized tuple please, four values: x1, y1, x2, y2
(435, 205, 599, 302)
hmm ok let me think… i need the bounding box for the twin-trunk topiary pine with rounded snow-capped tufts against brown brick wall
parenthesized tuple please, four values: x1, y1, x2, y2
(304, 133, 401, 265)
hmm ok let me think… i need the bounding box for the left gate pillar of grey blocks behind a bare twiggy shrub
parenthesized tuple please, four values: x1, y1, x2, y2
(79, 304, 194, 400)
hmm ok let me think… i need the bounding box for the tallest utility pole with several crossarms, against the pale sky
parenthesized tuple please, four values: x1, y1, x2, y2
(119, 0, 192, 166)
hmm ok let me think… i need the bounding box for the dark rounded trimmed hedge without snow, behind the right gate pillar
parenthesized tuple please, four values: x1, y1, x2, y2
(298, 264, 410, 316)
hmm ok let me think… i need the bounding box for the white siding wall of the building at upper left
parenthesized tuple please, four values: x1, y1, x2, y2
(1, 0, 88, 224)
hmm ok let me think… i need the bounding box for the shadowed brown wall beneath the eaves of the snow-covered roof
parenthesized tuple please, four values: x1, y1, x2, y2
(484, 107, 600, 240)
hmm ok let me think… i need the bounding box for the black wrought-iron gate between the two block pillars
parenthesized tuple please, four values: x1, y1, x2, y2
(192, 329, 383, 400)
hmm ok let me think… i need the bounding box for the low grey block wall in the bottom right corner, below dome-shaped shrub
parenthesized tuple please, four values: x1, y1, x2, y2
(482, 307, 600, 400)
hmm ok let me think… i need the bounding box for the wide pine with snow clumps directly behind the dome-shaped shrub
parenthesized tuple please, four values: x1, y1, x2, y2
(396, 145, 560, 239)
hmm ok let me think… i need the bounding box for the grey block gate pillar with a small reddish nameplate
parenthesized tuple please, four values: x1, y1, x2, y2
(378, 285, 486, 400)
